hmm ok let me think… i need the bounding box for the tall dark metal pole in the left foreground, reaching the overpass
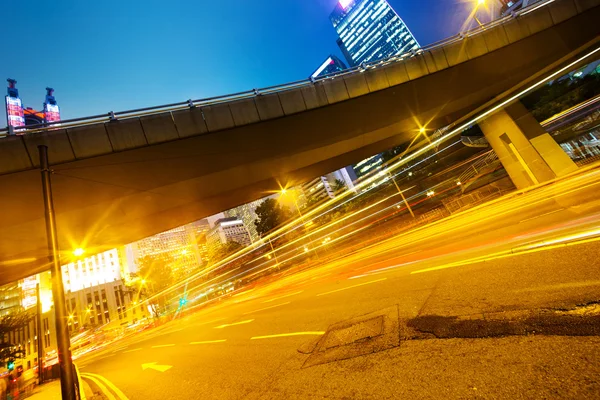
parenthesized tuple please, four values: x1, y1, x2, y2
(38, 145, 76, 400)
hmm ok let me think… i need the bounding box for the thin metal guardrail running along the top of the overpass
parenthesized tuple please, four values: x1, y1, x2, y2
(0, 0, 556, 137)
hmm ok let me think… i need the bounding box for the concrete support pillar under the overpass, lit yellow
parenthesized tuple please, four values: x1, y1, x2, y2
(479, 102, 577, 189)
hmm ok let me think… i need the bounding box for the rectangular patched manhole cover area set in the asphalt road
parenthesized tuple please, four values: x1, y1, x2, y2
(303, 306, 400, 368)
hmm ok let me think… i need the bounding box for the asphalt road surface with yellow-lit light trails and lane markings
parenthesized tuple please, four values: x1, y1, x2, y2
(77, 164, 600, 400)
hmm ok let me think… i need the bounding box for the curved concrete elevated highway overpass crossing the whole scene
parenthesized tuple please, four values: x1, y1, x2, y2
(0, 0, 600, 283)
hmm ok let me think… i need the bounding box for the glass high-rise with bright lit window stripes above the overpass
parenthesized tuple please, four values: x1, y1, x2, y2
(329, 0, 420, 66)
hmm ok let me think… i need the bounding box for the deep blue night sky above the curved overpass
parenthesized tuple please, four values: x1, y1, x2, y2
(0, 0, 472, 126)
